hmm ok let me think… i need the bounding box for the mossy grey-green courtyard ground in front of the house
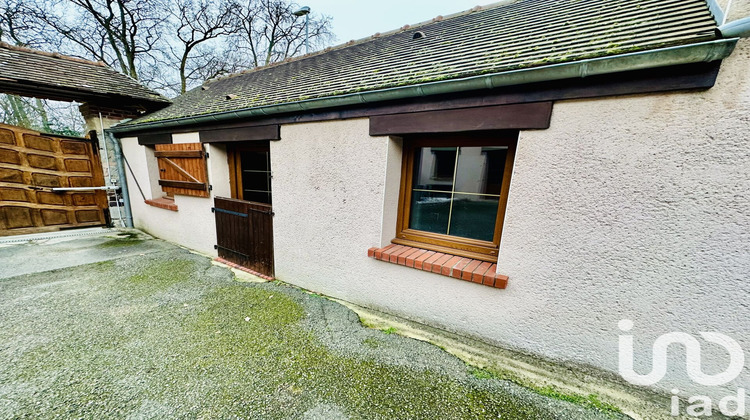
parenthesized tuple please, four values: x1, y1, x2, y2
(0, 236, 625, 419)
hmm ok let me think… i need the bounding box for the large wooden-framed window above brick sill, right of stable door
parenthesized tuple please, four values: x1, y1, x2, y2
(393, 131, 518, 262)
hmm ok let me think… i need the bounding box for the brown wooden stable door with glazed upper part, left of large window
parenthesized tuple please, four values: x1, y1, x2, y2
(214, 141, 273, 277)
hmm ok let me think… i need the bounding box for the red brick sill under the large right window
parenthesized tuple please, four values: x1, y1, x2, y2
(367, 244, 508, 289)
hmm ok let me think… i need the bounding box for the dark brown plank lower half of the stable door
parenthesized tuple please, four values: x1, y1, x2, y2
(213, 197, 274, 277)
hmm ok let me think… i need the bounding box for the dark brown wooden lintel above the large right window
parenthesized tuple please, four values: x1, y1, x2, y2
(370, 102, 552, 136)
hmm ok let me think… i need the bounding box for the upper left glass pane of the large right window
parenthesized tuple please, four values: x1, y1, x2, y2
(412, 147, 458, 191)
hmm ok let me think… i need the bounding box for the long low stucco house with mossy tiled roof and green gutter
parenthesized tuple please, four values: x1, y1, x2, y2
(112, 0, 750, 410)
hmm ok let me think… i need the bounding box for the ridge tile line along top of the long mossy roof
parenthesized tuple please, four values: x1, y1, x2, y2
(206, 0, 524, 86)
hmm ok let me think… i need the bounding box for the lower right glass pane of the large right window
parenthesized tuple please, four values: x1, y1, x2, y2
(449, 193, 500, 241)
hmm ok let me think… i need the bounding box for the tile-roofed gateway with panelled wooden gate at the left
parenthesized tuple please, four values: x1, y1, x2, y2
(0, 42, 169, 236)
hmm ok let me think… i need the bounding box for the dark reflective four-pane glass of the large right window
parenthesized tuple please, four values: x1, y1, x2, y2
(409, 146, 508, 241)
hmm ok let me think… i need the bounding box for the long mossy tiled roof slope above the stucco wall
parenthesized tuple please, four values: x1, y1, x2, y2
(130, 0, 716, 124)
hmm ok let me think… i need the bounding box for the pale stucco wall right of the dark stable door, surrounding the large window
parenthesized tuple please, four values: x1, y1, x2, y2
(271, 40, 750, 398)
